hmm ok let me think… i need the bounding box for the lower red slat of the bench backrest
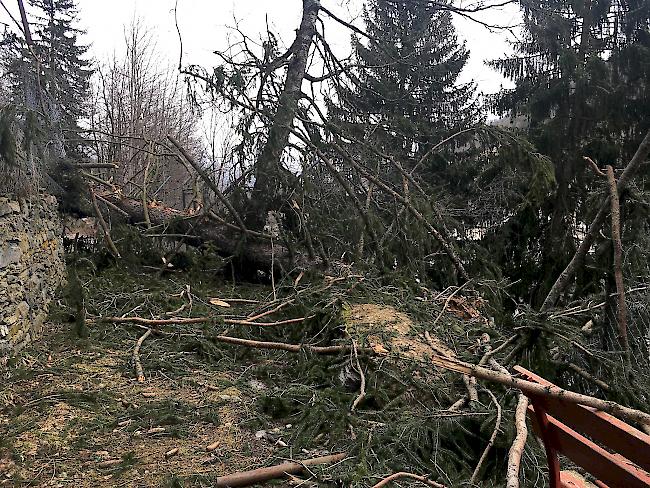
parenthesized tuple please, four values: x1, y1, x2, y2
(528, 405, 650, 488)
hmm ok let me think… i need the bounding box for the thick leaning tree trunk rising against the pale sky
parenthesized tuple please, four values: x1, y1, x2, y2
(246, 0, 320, 230)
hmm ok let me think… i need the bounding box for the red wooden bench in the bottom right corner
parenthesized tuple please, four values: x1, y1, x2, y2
(514, 366, 650, 488)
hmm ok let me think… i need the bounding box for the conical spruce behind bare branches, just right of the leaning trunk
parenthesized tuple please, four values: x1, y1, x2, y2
(329, 0, 481, 275)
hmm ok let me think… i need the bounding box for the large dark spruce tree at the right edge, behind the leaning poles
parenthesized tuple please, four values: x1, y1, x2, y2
(492, 0, 650, 305)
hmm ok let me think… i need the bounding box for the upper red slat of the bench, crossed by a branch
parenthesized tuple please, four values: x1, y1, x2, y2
(514, 366, 650, 472)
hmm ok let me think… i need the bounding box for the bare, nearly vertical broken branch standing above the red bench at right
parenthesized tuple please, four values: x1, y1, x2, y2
(606, 165, 629, 351)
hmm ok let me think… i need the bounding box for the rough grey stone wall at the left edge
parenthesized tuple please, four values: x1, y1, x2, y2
(0, 195, 65, 362)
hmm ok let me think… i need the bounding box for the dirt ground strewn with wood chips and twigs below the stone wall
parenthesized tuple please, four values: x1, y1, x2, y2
(0, 316, 284, 487)
